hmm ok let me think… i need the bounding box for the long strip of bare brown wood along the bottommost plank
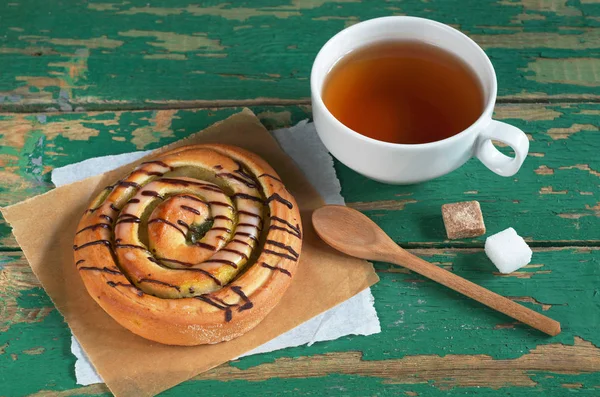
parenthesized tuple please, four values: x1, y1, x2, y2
(185, 337, 600, 389)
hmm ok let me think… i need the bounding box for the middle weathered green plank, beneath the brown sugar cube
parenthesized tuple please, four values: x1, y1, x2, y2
(0, 104, 600, 249)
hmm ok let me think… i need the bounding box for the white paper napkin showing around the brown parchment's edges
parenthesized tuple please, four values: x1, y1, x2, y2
(52, 120, 381, 385)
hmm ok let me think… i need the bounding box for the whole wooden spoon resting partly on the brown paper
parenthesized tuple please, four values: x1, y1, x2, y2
(312, 205, 560, 336)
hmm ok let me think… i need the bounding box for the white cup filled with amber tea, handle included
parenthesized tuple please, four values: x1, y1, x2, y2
(311, 16, 529, 184)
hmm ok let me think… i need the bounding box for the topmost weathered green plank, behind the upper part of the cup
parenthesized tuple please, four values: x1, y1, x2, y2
(0, 0, 600, 111)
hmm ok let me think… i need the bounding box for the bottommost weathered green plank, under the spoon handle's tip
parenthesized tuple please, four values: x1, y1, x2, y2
(0, 247, 600, 397)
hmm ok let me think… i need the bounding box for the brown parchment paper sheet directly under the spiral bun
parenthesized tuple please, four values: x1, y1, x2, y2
(2, 110, 378, 397)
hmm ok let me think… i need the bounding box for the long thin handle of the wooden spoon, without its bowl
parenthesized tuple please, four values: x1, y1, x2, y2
(390, 250, 560, 336)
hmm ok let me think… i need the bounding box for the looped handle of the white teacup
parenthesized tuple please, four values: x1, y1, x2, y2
(475, 120, 529, 176)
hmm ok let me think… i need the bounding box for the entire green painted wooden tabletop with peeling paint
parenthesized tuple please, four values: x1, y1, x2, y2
(0, 0, 600, 397)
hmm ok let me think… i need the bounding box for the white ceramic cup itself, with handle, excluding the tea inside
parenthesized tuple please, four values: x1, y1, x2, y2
(310, 16, 529, 184)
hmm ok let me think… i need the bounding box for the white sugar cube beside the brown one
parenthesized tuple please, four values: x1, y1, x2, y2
(485, 227, 532, 274)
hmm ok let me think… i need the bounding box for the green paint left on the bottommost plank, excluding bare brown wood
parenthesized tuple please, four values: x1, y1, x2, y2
(0, 248, 600, 396)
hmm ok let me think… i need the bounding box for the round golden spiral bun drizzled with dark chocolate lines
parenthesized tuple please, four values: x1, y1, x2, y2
(73, 144, 302, 345)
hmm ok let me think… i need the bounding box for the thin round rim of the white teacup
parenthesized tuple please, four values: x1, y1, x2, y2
(310, 16, 498, 148)
